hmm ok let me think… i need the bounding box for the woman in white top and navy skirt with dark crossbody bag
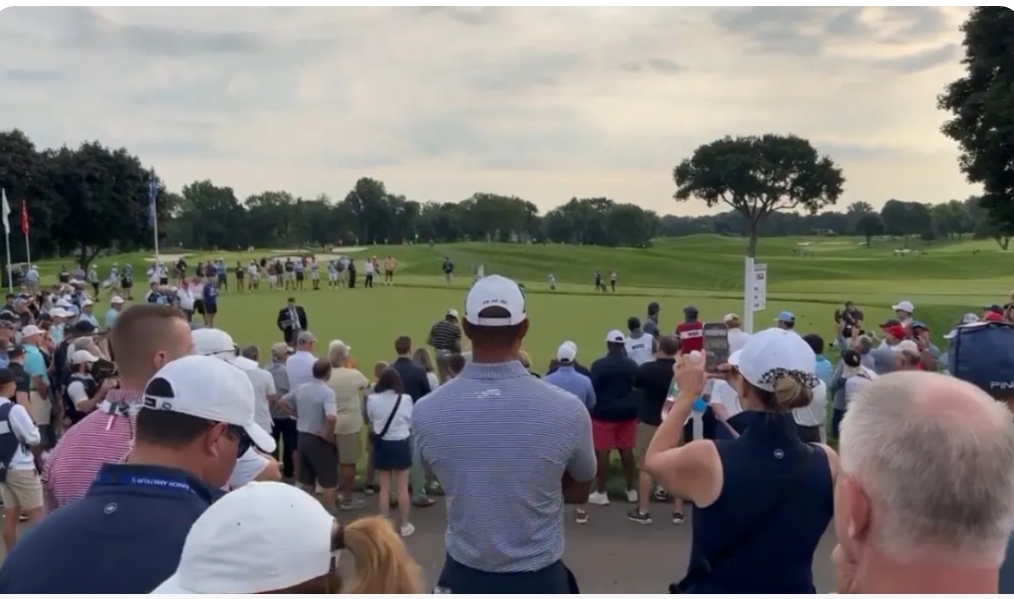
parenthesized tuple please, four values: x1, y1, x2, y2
(366, 368, 416, 537)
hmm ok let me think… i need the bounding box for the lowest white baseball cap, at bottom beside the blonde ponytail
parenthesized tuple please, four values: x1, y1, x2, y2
(152, 481, 337, 595)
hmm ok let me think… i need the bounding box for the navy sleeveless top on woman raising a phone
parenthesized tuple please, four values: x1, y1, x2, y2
(681, 411, 834, 594)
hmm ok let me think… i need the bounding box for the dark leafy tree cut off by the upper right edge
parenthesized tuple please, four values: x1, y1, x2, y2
(938, 6, 1014, 234)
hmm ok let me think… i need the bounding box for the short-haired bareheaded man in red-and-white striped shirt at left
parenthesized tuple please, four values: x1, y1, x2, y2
(43, 304, 194, 512)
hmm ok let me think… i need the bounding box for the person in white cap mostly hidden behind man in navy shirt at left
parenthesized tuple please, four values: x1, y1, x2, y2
(194, 328, 282, 489)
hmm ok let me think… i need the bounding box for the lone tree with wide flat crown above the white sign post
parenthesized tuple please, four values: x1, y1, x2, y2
(672, 134, 845, 257)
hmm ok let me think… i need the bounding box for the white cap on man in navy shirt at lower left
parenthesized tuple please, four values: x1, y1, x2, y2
(142, 356, 275, 453)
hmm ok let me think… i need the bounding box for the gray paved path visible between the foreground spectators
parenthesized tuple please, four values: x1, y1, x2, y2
(0, 499, 835, 594)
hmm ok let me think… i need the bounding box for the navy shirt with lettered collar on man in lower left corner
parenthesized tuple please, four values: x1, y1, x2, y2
(0, 464, 222, 595)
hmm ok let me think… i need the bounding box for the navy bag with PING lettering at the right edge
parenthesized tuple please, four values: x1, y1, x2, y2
(947, 322, 1014, 395)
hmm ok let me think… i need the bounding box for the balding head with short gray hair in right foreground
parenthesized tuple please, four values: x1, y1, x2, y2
(839, 371, 1014, 568)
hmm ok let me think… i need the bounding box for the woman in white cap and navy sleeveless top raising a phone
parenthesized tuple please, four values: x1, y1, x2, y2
(645, 328, 838, 594)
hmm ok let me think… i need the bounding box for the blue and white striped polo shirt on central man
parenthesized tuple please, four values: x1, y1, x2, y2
(412, 361, 595, 573)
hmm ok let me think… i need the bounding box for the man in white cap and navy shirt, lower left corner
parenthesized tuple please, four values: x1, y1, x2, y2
(0, 356, 274, 594)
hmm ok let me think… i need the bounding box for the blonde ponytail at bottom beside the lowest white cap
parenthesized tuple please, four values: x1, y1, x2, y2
(341, 516, 423, 595)
